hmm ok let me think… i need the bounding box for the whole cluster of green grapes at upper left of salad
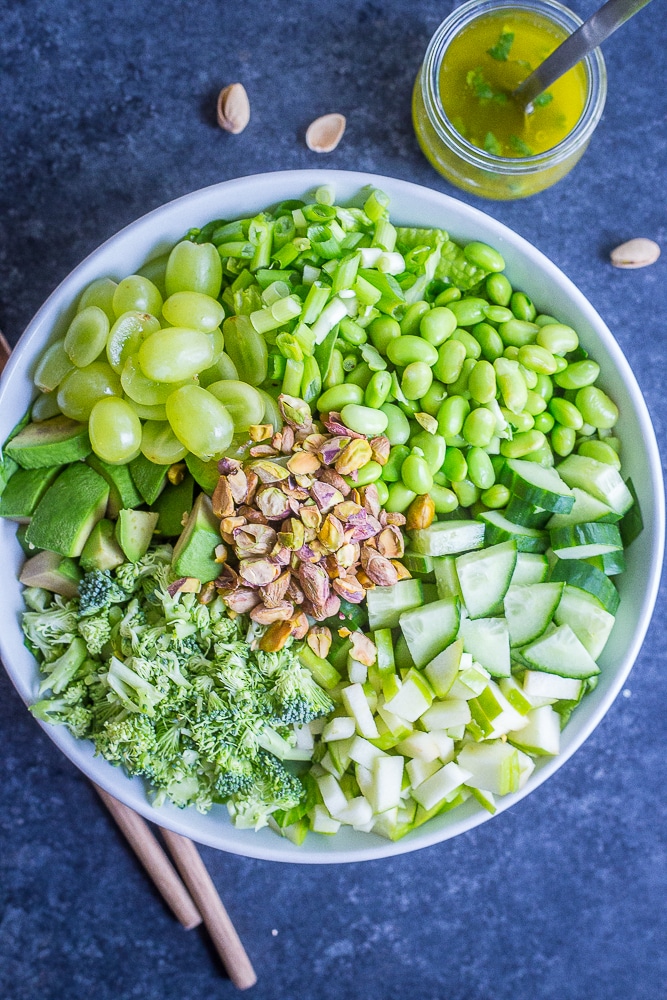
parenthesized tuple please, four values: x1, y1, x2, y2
(32, 240, 266, 465)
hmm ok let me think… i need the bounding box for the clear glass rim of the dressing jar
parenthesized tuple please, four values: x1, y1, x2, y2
(420, 0, 607, 176)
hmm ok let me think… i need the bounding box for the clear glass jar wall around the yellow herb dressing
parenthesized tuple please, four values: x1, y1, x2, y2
(412, 0, 607, 200)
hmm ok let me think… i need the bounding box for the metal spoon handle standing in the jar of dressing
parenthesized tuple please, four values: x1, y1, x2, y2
(512, 0, 651, 114)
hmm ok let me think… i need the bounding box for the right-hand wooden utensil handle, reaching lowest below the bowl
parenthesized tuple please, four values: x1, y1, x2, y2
(160, 827, 257, 990)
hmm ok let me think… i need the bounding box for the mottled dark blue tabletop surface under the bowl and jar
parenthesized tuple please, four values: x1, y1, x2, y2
(0, 0, 667, 1000)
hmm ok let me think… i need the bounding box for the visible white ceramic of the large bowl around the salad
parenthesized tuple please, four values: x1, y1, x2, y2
(0, 170, 665, 863)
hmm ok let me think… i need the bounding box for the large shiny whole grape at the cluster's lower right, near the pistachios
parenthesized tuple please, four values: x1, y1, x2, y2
(167, 385, 235, 462)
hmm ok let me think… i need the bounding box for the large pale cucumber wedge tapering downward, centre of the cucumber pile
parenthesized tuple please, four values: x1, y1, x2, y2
(456, 540, 516, 618)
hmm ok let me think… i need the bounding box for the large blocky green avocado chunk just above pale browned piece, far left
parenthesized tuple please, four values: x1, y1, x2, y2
(25, 462, 109, 556)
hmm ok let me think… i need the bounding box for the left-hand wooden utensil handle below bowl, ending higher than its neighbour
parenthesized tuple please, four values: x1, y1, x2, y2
(93, 785, 202, 931)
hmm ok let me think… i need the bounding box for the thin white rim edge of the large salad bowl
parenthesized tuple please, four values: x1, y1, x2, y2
(0, 168, 665, 864)
